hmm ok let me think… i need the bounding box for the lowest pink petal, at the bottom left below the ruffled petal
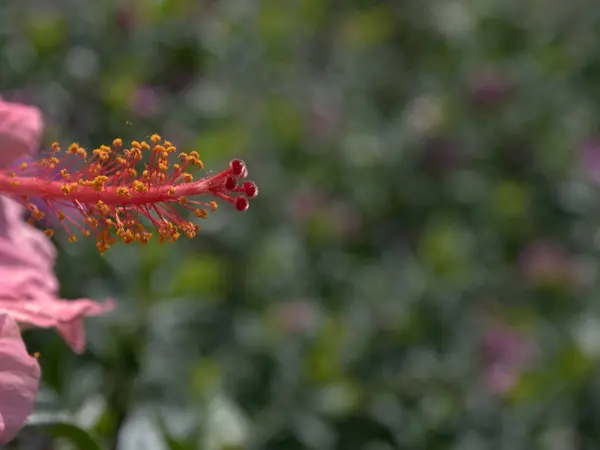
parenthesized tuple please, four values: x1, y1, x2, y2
(0, 314, 41, 444)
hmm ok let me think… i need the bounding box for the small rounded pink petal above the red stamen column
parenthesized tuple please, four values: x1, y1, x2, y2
(0, 99, 43, 167)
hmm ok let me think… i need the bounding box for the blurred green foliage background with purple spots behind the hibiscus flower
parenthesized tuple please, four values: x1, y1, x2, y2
(0, 0, 600, 450)
